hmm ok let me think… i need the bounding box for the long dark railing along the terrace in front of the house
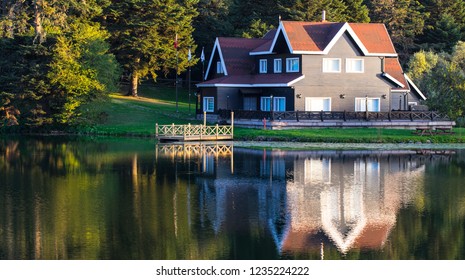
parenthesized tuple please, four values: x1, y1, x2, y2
(218, 110, 450, 121)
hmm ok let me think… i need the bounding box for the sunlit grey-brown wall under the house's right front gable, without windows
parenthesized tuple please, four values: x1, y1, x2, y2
(294, 34, 391, 111)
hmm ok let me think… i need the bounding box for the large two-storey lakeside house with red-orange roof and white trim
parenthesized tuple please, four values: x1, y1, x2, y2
(197, 18, 426, 117)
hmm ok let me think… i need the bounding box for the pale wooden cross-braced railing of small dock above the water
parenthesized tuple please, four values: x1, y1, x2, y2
(155, 124, 234, 141)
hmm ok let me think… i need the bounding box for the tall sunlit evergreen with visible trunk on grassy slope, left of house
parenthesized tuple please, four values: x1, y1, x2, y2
(106, 0, 198, 96)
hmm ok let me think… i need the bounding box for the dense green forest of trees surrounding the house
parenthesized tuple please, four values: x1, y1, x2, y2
(0, 0, 465, 129)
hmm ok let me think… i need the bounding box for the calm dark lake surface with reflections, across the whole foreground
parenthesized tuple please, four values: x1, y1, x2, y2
(0, 137, 465, 260)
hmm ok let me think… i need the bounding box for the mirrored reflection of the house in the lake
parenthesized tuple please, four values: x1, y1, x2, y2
(197, 148, 425, 253)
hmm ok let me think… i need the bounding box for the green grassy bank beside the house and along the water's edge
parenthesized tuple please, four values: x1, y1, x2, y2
(79, 86, 465, 143)
